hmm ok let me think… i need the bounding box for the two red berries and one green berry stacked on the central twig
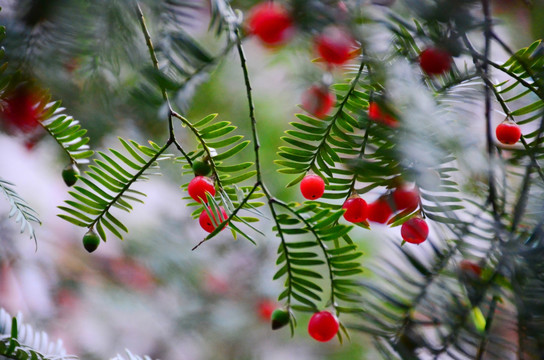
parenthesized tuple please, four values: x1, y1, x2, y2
(187, 160, 228, 233)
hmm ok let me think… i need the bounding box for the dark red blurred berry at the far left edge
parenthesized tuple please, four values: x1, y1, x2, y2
(1, 87, 40, 133)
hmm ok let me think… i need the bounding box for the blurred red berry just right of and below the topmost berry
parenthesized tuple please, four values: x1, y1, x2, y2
(314, 27, 355, 65)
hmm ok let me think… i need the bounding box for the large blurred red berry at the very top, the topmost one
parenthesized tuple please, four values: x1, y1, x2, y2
(248, 2, 293, 45)
